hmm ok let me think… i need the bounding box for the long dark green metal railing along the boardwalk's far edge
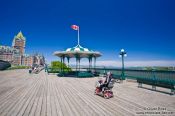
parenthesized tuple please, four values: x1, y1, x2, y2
(45, 67, 175, 81)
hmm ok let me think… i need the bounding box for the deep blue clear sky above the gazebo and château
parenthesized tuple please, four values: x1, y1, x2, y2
(0, 0, 175, 65)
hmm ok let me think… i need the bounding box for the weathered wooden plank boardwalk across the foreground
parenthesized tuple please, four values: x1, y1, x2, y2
(0, 70, 175, 116)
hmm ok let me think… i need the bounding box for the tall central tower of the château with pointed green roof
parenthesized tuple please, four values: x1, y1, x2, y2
(12, 31, 26, 55)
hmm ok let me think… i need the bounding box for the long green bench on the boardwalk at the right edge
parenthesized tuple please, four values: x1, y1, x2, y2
(137, 78, 175, 95)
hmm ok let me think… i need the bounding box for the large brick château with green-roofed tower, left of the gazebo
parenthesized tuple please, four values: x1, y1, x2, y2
(0, 31, 45, 66)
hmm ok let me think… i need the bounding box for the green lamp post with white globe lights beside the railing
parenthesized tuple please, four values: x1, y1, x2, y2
(119, 49, 127, 80)
